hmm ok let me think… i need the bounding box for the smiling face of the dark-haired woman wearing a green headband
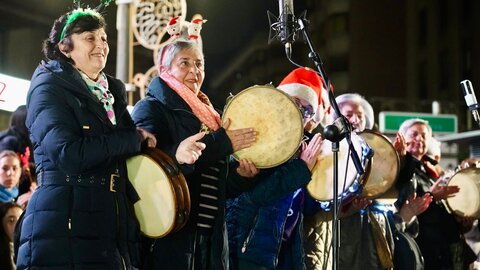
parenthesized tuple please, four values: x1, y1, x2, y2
(59, 28, 110, 80)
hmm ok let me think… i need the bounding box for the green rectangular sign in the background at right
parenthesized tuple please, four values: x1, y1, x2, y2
(379, 112, 457, 134)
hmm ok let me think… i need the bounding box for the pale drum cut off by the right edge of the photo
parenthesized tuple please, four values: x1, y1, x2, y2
(447, 167, 480, 218)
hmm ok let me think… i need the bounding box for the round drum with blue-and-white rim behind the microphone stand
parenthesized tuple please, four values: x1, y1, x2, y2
(307, 133, 371, 211)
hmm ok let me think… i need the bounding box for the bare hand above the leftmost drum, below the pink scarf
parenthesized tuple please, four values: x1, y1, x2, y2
(175, 132, 206, 164)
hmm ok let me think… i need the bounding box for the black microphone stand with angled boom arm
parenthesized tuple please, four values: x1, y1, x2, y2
(297, 16, 364, 270)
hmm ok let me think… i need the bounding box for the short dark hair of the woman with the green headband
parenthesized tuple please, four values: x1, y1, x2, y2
(42, 12, 107, 63)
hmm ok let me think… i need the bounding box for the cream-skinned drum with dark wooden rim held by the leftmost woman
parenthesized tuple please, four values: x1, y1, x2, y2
(127, 148, 190, 238)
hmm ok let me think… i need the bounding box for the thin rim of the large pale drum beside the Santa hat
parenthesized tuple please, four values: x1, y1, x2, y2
(222, 85, 304, 169)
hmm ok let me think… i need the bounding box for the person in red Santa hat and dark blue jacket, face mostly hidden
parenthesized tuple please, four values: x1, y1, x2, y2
(227, 68, 323, 270)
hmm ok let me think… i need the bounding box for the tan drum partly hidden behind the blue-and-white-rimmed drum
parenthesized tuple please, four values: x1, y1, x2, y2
(359, 130, 400, 199)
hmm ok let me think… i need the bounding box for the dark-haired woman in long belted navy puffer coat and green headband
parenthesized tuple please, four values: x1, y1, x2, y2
(17, 8, 203, 270)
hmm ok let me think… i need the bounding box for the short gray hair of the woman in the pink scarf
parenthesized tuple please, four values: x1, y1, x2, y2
(157, 39, 203, 71)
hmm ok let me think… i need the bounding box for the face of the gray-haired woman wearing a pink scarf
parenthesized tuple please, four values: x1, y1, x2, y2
(168, 49, 205, 94)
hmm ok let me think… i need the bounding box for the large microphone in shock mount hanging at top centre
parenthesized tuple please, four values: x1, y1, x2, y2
(267, 0, 299, 59)
